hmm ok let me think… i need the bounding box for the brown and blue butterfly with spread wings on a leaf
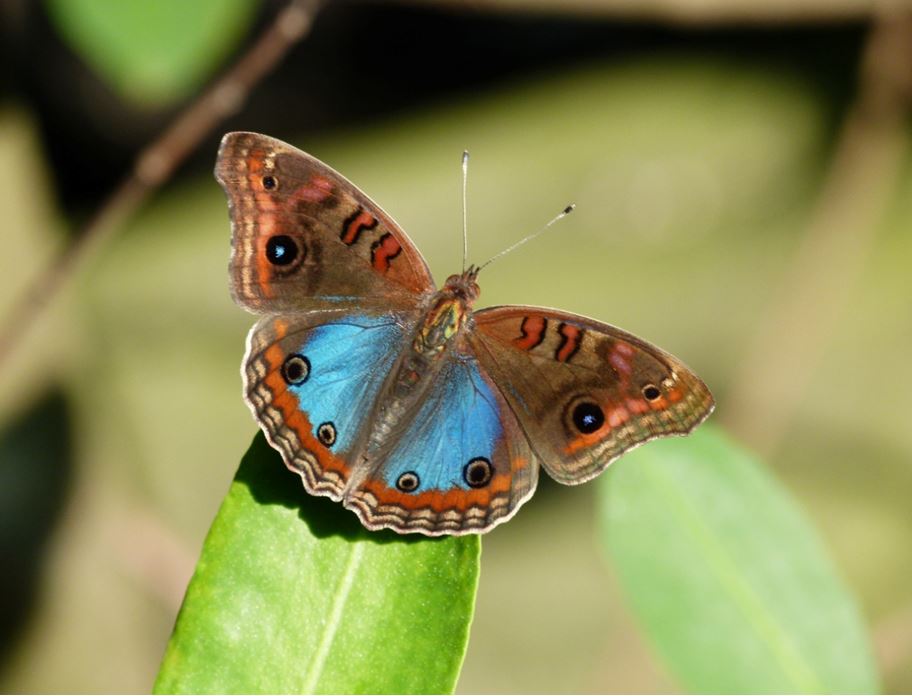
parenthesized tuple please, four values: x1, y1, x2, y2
(215, 132, 714, 536)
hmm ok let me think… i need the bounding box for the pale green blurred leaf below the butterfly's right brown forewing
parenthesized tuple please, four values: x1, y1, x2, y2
(599, 426, 878, 693)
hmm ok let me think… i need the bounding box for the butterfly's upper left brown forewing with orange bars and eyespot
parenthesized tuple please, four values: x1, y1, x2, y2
(215, 132, 434, 313)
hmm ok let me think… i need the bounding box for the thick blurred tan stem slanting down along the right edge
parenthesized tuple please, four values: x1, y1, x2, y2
(723, 10, 912, 454)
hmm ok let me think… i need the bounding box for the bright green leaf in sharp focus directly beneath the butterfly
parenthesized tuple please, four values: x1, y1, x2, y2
(155, 434, 481, 693)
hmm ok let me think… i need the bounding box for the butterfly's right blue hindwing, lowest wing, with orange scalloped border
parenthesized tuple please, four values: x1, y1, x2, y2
(343, 354, 538, 535)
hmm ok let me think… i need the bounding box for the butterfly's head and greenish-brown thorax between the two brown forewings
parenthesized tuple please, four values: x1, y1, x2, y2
(412, 266, 479, 357)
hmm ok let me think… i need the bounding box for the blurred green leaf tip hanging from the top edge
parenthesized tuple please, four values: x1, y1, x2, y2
(47, 0, 258, 105)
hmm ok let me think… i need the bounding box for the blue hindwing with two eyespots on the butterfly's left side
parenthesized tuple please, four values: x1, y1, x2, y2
(243, 312, 414, 500)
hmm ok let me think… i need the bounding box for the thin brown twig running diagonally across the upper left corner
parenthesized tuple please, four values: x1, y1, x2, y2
(0, 0, 318, 376)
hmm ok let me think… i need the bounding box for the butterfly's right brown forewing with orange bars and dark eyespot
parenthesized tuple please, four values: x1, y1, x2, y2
(470, 307, 714, 484)
